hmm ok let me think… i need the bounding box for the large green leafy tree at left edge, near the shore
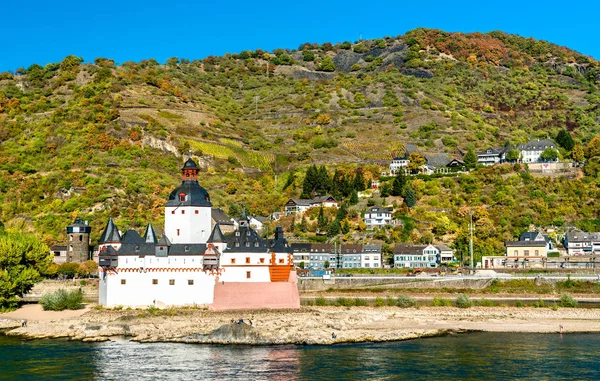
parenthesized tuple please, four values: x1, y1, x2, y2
(0, 233, 52, 308)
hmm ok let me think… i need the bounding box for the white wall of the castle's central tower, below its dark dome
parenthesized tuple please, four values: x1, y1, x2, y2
(165, 206, 211, 243)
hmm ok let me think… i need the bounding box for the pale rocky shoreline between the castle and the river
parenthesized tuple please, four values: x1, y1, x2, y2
(0, 307, 600, 345)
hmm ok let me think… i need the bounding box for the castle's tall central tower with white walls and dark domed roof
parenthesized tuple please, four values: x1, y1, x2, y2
(165, 158, 212, 244)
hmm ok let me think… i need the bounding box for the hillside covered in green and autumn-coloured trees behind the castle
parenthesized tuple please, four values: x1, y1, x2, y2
(0, 29, 600, 255)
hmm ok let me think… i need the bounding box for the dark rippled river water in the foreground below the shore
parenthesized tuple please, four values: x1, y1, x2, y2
(0, 333, 600, 381)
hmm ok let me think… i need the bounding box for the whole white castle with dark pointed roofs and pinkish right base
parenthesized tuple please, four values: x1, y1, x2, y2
(99, 159, 300, 310)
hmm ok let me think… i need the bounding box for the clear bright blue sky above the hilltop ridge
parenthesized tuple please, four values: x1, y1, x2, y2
(0, 0, 600, 71)
